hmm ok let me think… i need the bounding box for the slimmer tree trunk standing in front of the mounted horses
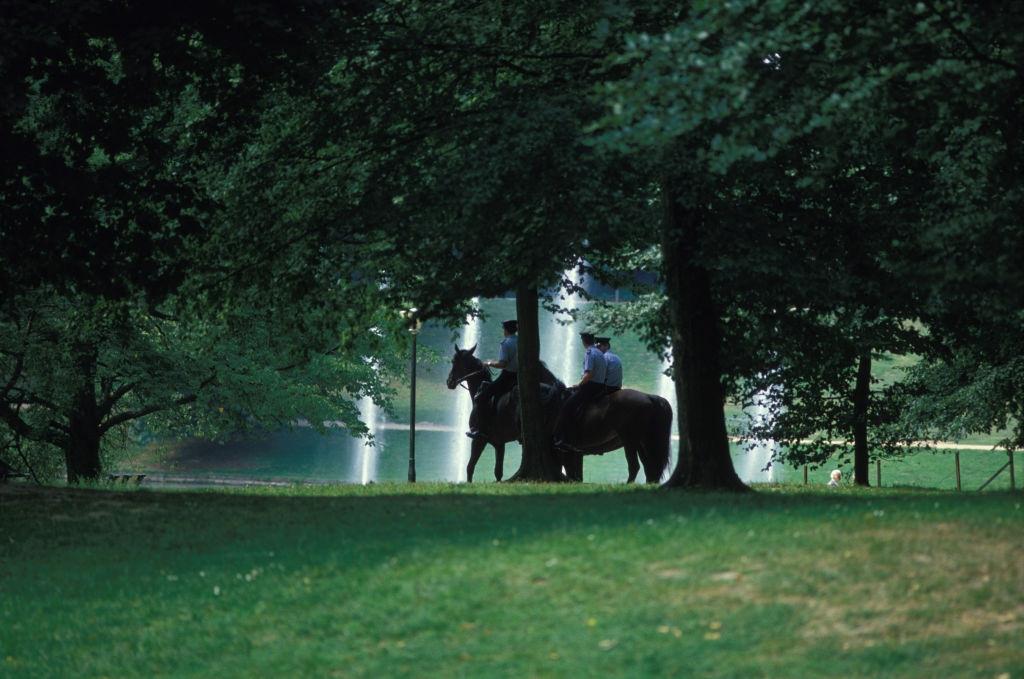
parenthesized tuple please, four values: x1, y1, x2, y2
(509, 286, 561, 481)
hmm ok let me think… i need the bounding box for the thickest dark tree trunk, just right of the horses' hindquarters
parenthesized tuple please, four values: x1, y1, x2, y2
(662, 181, 748, 491)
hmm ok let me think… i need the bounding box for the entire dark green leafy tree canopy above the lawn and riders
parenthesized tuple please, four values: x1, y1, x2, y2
(0, 0, 1024, 489)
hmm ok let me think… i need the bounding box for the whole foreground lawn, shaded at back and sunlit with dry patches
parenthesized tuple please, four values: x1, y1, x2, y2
(0, 484, 1024, 678)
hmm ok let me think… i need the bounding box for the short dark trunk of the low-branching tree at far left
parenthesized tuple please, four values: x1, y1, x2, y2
(65, 343, 101, 483)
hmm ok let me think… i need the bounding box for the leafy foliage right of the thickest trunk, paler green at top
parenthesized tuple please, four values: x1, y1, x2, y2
(590, 2, 1024, 460)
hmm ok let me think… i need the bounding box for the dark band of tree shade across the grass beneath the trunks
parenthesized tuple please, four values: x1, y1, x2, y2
(0, 484, 1021, 565)
